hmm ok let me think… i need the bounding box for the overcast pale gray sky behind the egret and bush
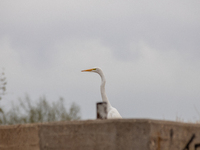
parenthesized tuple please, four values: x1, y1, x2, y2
(0, 0, 200, 121)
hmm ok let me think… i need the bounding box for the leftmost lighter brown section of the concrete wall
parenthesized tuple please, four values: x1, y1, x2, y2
(0, 125, 40, 150)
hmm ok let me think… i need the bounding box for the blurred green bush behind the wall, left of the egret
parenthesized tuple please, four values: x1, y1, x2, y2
(0, 96, 80, 125)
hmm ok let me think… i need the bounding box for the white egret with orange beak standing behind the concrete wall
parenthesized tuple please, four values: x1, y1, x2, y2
(82, 68, 122, 119)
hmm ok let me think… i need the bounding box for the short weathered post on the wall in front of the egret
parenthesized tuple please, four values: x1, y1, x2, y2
(97, 102, 108, 119)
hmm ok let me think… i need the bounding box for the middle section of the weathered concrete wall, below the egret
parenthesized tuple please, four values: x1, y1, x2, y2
(40, 120, 149, 150)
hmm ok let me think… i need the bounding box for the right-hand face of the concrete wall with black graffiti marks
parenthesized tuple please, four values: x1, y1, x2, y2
(149, 120, 200, 150)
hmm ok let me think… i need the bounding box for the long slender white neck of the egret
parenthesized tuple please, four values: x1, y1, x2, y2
(99, 72, 111, 108)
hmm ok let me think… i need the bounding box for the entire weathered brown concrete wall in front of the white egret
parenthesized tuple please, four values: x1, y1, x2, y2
(0, 119, 200, 150)
